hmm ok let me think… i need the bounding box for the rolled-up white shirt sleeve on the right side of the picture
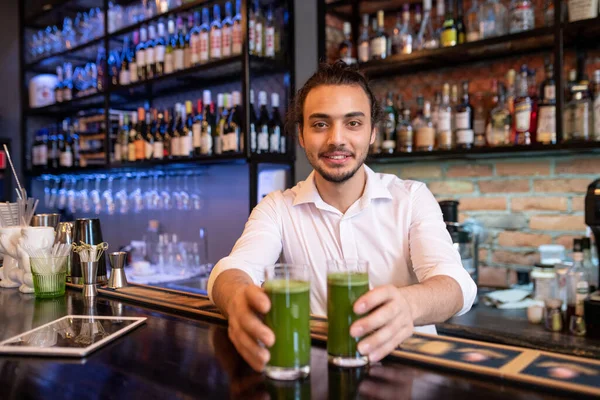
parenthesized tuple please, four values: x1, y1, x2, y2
(409, 184, 477, 315)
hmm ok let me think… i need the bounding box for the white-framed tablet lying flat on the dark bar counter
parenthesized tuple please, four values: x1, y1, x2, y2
(0, 315, 146, 357)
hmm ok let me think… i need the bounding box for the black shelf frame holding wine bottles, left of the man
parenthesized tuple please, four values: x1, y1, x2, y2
(19, 0, 296, 210)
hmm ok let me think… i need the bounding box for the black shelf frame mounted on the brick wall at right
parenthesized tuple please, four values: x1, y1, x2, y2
(317, 0, 600, 163)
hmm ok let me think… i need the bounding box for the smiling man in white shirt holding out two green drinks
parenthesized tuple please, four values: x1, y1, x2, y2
(208, 61, 477, 371)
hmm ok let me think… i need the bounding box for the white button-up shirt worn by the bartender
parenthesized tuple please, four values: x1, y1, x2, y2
(208, 166, 477, 333)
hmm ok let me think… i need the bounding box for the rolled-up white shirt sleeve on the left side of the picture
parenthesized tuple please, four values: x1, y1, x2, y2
(207, 192, 282, 301)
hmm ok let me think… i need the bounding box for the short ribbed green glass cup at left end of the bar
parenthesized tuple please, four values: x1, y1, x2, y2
(29, 256, 69, 299)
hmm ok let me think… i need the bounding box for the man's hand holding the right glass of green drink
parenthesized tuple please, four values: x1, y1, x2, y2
(350, 285, 414, 363)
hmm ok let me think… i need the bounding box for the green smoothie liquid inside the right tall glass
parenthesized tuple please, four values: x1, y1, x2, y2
(327, 272, 369, 358)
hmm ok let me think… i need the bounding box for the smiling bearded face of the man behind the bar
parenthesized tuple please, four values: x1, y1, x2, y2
(299, 85, 375, 183)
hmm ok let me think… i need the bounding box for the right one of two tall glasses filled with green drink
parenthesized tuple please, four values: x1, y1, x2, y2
(327, 260, 369, 367)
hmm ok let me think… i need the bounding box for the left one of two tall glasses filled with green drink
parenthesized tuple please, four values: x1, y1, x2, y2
(263, 264, 310, 380)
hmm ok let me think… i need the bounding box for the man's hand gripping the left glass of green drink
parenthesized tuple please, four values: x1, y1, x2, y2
(227, 284, 275, 372)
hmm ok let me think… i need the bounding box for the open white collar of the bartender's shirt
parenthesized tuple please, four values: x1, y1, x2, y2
(293, 165, 393, 208)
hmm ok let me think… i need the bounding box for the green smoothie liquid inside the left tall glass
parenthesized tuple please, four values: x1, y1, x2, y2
(263, 279, 310, 368)
